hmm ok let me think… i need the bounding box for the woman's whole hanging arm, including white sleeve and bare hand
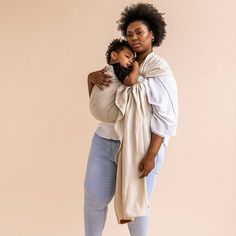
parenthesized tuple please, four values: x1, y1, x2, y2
(140, 75, 178, 177)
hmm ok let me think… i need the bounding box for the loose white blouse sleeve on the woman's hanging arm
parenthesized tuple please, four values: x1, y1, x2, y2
(144, 75, 178, 138)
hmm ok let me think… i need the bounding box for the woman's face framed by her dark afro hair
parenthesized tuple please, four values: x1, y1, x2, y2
(126, 21, 154, 54)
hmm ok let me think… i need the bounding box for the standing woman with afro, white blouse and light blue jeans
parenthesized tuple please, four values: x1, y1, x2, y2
(84, 3, 178, 236)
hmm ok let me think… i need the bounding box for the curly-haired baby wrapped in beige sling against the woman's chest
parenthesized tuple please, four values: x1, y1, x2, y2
(89, 39, 139, 122)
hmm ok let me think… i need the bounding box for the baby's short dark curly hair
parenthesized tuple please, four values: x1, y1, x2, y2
(106, 39, 135, 64)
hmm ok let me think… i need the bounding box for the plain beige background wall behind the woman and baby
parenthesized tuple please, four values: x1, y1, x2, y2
(0, 0, 236, 236)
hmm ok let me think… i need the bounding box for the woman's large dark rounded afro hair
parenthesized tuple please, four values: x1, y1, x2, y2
(117, 3, 166, 47)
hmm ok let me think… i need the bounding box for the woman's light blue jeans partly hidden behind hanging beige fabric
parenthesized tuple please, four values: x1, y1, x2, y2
(84, 133, 165, 236)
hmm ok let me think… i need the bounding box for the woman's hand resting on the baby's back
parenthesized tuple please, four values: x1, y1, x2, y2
(88, 67, 112, 90)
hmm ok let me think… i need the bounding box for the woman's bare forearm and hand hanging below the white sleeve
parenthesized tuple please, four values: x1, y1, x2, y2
(139, 133, 164, 178)
